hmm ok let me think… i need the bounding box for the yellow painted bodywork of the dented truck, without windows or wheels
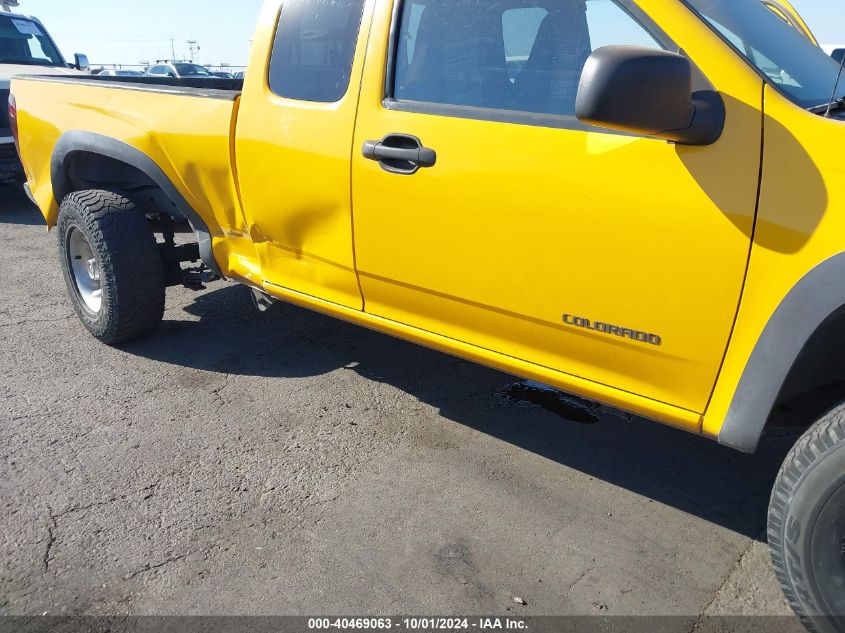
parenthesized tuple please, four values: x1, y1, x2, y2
(13, 0, 845, 450)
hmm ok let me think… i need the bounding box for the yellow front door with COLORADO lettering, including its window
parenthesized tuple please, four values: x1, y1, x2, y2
(353, 0, 762, 412)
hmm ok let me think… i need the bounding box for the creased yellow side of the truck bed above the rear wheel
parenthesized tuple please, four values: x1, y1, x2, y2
(11, 75, 246, 242)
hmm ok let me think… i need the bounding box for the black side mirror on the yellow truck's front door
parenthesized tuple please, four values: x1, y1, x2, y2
(575, 46, 725, 145)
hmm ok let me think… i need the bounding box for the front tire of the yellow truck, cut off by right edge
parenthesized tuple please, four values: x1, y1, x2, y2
(768, 406, 845, 633)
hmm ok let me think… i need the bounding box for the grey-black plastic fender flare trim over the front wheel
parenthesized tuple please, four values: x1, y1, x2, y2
(719, 253, 845, 453)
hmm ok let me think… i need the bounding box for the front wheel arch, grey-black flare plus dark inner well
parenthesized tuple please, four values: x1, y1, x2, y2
(718, 253, 845, 453)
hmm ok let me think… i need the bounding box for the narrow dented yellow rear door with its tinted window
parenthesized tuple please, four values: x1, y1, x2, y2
(235, 0, 372, 310)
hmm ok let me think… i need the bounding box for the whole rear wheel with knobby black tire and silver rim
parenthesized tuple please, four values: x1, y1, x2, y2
(57, 190, 165, 345)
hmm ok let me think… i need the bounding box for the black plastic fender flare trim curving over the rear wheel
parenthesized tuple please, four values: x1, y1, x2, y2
(50, 130, 222, 277)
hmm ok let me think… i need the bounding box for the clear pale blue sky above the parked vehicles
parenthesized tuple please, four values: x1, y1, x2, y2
(17, 0, 845, 66)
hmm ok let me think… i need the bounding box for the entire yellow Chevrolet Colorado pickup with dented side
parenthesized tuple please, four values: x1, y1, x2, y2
(10, 0, 845, 631)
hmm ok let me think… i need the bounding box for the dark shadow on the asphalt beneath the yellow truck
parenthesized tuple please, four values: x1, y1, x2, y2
(124, 286, 800, 540)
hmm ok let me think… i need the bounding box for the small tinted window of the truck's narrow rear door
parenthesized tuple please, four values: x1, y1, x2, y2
(270, 0, 364, 102)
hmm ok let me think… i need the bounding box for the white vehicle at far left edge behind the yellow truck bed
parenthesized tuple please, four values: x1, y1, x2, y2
(0, 12, 88, 184)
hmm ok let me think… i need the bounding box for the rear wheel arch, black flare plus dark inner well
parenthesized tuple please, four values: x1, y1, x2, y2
(50, 131, 220, 275)
